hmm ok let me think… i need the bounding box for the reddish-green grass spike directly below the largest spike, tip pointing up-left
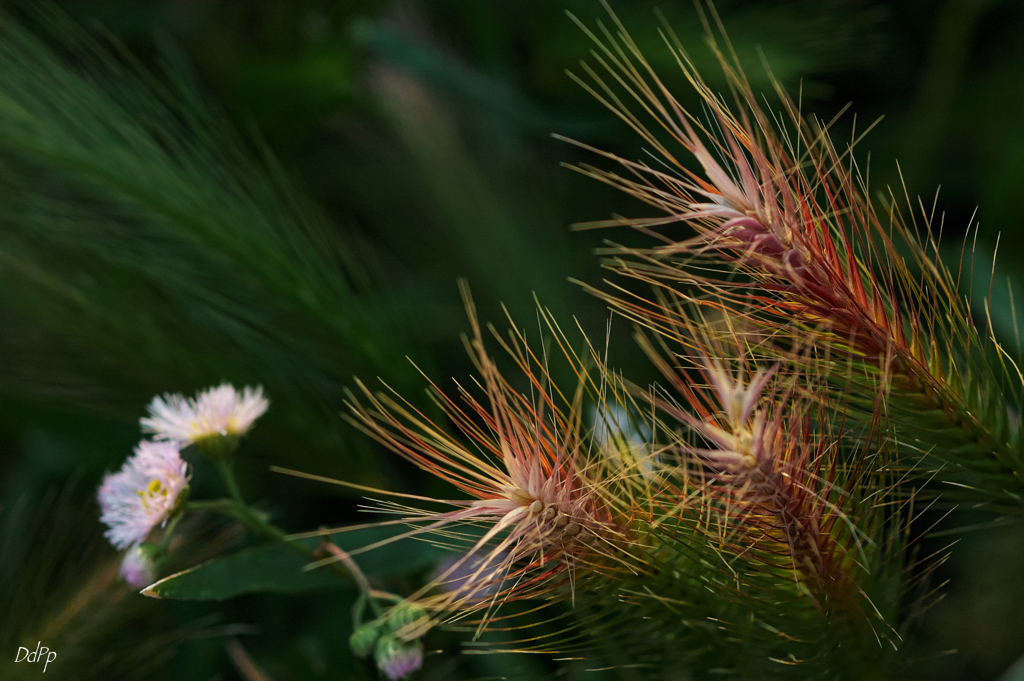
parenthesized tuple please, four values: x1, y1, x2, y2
(645, 340, 903, 678)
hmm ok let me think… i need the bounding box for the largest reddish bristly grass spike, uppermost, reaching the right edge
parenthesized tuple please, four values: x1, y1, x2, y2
(568, 3, 1024, 502)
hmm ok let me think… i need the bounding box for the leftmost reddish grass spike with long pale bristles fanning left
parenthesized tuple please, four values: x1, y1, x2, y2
(299, 286, 620, 628)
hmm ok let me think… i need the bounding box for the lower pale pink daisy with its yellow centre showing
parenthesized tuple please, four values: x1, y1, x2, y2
(97, 440, 189, 549)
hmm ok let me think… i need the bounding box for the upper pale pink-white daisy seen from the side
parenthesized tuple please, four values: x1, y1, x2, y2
(139, 383, 270, 444)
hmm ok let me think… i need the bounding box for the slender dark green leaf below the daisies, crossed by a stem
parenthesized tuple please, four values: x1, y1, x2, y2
(142, 527, 447, 600)
